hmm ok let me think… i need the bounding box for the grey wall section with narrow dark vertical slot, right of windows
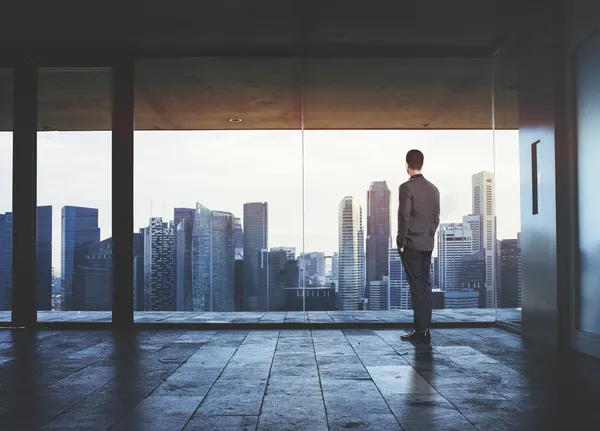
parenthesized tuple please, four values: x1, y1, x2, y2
(518, 2, 559, 346)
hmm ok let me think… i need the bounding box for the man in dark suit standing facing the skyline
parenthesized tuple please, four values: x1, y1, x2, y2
(396, 150, 440, 342)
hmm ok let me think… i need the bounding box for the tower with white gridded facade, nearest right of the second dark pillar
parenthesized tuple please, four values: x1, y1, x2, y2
(144, 217, 175, 311)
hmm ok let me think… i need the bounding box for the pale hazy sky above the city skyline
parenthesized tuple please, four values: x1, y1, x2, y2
(0, 130, 521, 273)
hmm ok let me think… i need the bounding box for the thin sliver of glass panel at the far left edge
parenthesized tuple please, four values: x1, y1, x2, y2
(0, 70, 13, 322)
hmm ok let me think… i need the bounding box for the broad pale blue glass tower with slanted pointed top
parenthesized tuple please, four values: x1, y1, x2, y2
(192, 204, 235, 311)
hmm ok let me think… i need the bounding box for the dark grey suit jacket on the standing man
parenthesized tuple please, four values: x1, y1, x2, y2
(396, 174, 440, 251)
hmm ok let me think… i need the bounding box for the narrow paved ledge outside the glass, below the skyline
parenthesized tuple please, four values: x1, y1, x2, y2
(0, 308, 521, 326)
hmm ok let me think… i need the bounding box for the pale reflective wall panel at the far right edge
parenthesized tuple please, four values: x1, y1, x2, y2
(564, 0, 600, 357)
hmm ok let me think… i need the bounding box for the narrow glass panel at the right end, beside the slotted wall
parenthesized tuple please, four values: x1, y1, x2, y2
(492, 52, 523, 323)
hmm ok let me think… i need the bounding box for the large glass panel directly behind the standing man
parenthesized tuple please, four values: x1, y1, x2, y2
(303, 59, 498, 322)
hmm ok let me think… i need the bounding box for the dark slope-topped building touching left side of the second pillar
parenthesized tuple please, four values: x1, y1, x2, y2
(79, 238, 113, 311)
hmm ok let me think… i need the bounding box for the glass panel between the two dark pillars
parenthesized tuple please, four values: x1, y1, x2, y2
(37, 68, 113, 321)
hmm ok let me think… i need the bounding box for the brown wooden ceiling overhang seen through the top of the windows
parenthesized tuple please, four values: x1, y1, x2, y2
(0, 58, 518, 130)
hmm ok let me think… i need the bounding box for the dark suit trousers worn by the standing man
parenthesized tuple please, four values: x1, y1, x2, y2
(400, 248, 433, 331)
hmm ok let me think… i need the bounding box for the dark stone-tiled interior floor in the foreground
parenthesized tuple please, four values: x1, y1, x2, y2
(0, 328, 600, 431)
